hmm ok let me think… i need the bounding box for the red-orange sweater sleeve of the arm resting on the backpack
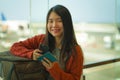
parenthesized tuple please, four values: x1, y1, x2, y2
(10, 34, 44, 58)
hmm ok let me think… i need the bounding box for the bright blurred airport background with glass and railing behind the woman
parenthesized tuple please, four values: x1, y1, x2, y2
(0, 0, 120, 80)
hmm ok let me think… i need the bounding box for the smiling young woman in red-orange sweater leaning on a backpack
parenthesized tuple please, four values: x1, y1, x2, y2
(10, 5, 83, 80)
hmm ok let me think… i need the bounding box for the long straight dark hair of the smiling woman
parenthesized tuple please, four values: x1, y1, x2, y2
(45, 5, 77, 68)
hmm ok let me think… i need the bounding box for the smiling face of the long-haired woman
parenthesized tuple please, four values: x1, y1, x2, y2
(47, 12, 63, 38)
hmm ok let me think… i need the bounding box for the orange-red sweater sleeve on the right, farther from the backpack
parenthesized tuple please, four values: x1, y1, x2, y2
(48, 46, 83, 80)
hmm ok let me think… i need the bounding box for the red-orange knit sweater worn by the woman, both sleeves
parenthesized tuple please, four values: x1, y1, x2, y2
(10, 34, 83, 80)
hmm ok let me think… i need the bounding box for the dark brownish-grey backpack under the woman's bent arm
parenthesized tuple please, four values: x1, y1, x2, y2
(0, 51, 49, 80)
